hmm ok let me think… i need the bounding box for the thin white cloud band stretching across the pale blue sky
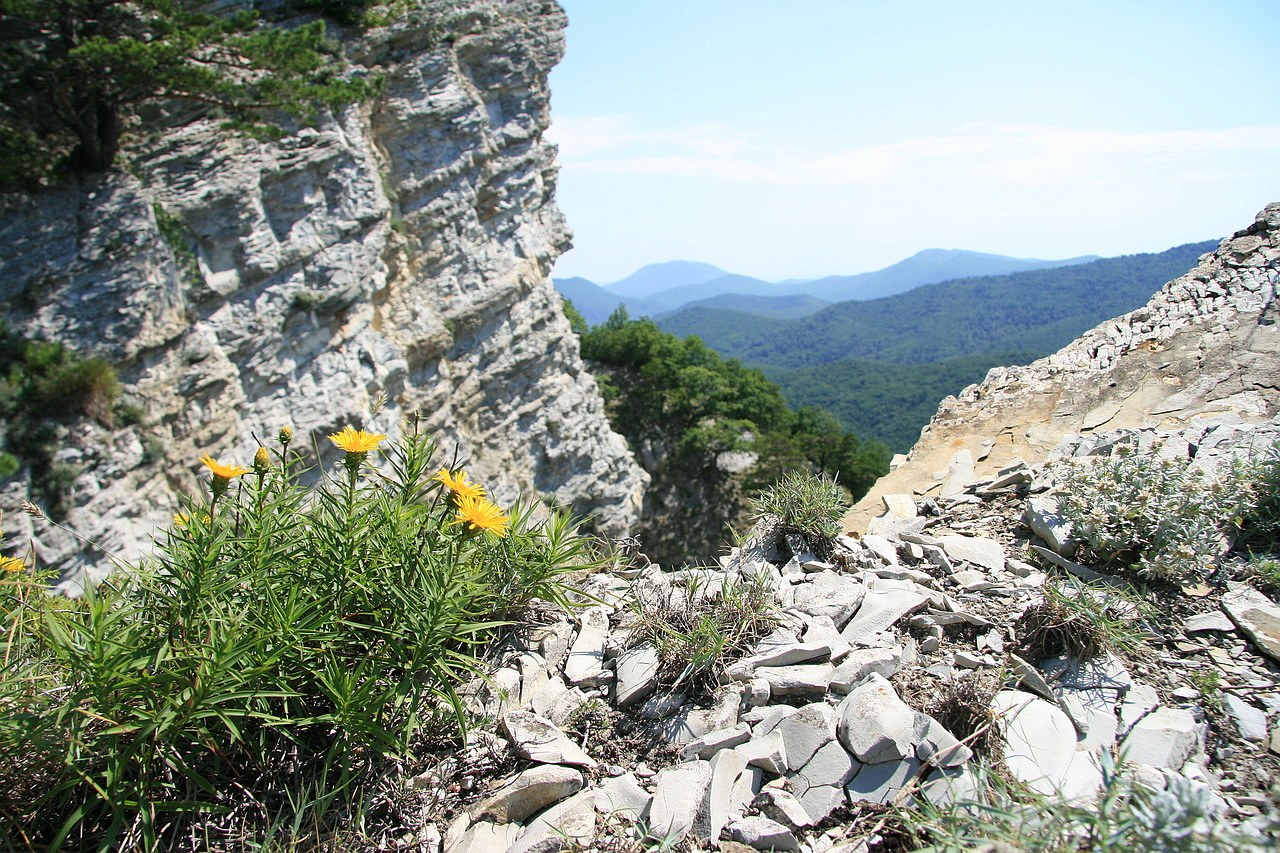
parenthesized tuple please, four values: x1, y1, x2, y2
(552, 115, 1280, 186)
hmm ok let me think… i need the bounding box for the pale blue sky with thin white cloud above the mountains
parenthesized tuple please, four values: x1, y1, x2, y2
(548, 0, 1280, 283)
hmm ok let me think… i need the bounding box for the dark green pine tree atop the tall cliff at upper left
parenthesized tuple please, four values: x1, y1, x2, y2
(0, 0, 367, 183)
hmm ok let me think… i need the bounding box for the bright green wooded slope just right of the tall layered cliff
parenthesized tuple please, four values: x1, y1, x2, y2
(566, 302, 890, 562)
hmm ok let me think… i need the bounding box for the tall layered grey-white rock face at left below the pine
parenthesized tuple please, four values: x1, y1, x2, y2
(0, 0, 648, 571)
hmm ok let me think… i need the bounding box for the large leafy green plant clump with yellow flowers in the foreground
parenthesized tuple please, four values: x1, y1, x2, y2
(0, 422, 589, 849)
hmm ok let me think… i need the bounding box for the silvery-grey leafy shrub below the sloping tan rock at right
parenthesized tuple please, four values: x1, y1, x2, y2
(1059, 440, 1277, 581)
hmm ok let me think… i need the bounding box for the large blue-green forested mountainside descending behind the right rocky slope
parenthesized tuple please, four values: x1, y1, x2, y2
(658, 242, 1216, 453)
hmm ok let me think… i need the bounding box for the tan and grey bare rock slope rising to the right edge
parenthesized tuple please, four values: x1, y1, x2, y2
(845, 204, 1280, 530)
